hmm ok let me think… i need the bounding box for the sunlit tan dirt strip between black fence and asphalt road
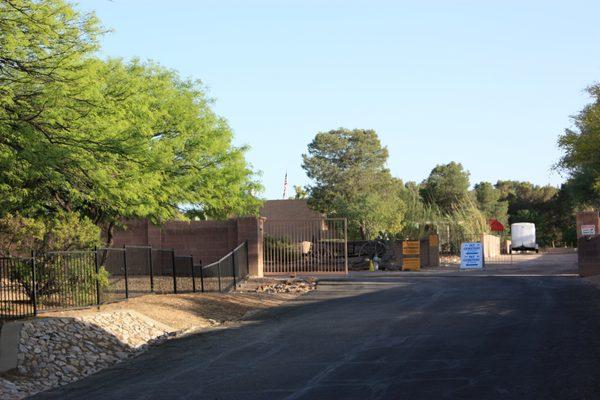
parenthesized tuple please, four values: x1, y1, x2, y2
(40, 293, 297, 331)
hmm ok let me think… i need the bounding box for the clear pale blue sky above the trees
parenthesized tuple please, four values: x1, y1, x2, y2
(79, 0, 600, 199)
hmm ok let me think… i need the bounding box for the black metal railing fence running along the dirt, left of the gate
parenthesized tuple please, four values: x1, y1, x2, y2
(0, 242, 248, 320)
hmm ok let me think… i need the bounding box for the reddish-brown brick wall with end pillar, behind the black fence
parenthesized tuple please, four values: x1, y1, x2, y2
(113, 217, 264, 276)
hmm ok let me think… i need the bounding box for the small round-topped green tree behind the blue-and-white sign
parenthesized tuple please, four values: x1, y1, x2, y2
(421, 161, 469, 213)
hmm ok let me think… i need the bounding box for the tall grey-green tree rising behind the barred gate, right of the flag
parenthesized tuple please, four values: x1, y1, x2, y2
(302, 128, 405, 239)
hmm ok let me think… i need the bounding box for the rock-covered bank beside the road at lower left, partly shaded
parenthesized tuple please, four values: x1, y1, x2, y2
(0, 311, 175, 399)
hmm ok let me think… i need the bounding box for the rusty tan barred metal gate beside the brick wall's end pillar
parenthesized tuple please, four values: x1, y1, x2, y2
(263, 218, 348, 275)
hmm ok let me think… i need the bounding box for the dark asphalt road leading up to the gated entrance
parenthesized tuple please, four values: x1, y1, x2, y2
(38, 255, 600, 399)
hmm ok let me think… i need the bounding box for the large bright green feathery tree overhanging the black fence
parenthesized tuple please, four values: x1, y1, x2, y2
(0, 0, 260, 247)
